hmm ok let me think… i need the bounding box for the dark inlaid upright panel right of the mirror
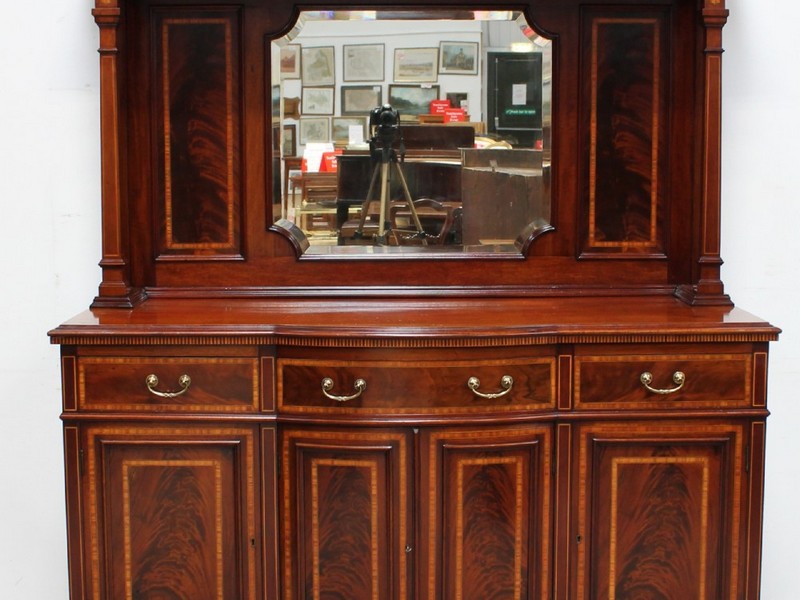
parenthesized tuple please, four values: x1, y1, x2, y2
(583, 10, 669, 255)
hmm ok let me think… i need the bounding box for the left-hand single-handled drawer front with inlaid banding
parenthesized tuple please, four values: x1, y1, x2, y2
(78, 357, 258, 413)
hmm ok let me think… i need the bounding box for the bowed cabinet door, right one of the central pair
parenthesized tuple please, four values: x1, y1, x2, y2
(419, 426, 552, 600)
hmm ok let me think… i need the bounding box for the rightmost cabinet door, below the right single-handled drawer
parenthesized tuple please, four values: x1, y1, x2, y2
(569, 421, 747, 600)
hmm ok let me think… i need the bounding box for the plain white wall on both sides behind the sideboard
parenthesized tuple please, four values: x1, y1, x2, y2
(0, 0, 800, 600)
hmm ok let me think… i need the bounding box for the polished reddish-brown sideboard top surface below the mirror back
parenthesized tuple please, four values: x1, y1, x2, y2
(50, 296, 779, 346)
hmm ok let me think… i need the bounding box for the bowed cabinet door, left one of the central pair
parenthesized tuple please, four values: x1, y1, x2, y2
(281, 428, 412, 600)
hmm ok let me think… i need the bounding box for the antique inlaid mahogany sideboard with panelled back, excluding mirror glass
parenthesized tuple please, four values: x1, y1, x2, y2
(50, 0, 779, 600)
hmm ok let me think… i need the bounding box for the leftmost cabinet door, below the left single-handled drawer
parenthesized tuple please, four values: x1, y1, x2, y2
(82, 425, 263, 600)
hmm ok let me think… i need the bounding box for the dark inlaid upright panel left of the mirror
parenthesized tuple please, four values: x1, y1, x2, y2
(151, 8, 241, 257)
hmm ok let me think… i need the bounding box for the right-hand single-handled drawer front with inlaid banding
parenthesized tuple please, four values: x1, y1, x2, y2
(574, 354, 753, 409)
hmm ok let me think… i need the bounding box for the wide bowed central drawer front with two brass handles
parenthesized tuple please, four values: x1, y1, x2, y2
(278, 357, 556, 415)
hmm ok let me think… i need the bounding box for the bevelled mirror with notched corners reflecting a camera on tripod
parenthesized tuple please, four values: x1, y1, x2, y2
(271, 9, 552, 256)
